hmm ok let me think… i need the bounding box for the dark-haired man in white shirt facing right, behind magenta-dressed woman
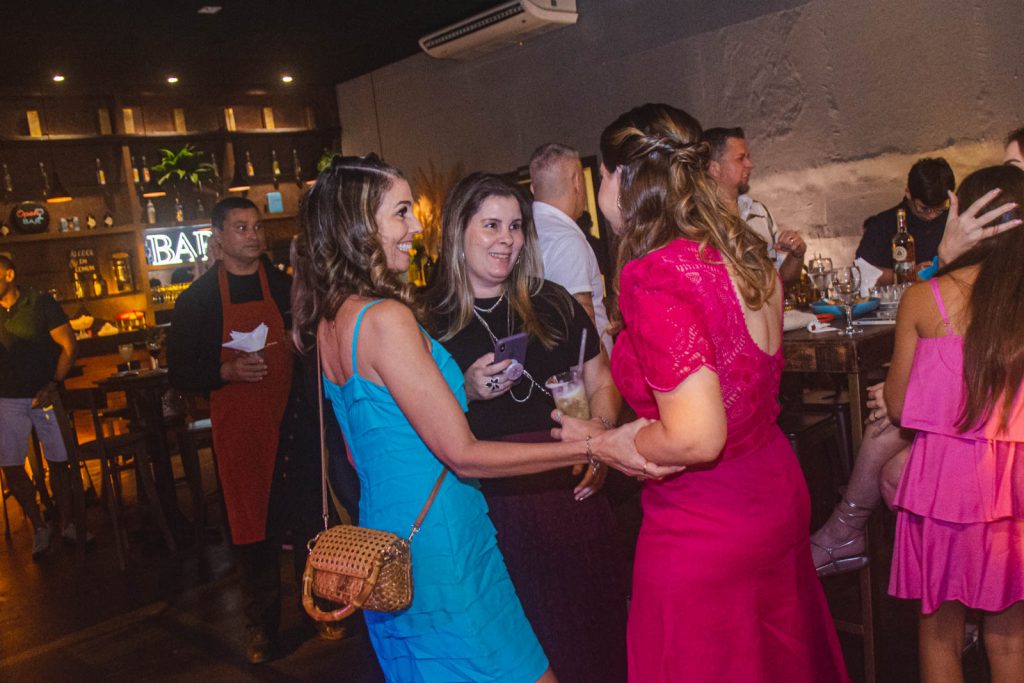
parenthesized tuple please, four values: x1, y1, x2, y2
(705, 128, 807, 285)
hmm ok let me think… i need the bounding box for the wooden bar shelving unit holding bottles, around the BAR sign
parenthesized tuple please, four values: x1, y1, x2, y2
(0, 88, 340, 324)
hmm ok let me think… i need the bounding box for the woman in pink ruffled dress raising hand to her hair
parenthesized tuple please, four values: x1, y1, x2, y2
(888, 166, 1024, 683)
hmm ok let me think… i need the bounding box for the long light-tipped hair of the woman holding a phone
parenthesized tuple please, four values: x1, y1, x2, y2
(427, 173, 572, 349)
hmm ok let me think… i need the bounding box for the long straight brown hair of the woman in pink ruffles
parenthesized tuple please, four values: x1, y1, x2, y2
(939, 166, 1024, 432)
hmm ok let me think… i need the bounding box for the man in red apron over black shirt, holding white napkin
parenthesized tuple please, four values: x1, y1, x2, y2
(168, 197, 294, 664)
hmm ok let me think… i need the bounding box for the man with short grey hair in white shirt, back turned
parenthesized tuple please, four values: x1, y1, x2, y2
(529, 142, 611, 355)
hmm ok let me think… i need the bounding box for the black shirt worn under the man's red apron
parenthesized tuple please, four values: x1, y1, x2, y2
(167, 259, 292, 393)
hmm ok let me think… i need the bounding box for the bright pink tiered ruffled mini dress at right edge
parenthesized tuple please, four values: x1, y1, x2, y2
(889, 280, 1024, 614)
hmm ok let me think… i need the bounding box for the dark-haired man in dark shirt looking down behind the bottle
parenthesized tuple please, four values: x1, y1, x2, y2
(857, 157, 956, 287)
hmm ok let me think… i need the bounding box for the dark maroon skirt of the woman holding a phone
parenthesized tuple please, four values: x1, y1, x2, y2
(480, 432, 628, 683)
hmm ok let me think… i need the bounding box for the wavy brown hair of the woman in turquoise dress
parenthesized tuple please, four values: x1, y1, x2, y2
(292, 155, 417, 349)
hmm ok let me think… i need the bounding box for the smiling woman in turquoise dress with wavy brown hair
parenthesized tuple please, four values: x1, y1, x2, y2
(293, 157, 671, 683)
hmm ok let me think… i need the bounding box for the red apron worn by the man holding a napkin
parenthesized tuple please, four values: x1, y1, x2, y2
(210, 263, 292, 545)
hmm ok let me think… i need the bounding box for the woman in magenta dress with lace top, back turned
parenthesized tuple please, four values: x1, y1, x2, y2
(562, 104, 848, 683)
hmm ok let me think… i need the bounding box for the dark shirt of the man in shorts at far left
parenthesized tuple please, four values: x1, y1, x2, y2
(0, 287, 68, 398)
